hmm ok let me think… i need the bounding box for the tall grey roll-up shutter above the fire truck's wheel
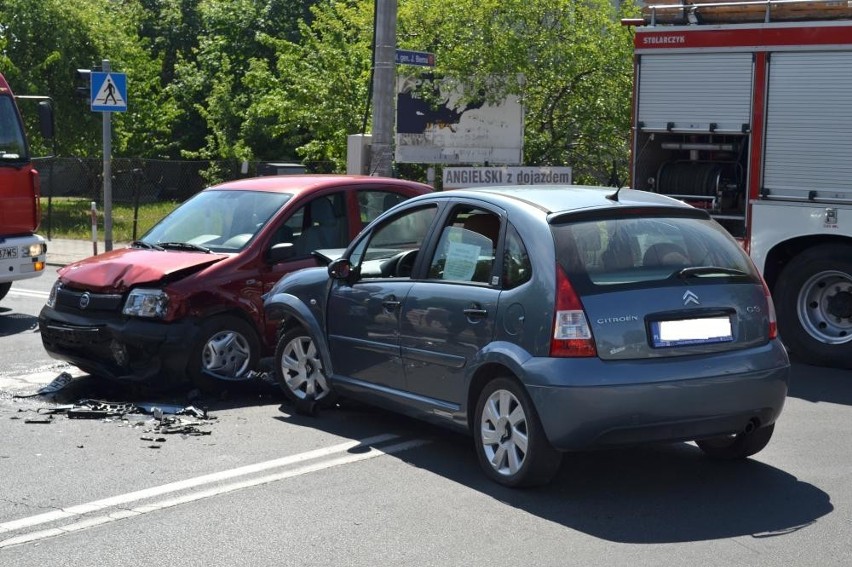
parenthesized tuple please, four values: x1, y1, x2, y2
(763, 50, 852, 200)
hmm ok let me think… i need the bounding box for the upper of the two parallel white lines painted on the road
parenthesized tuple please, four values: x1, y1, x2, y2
(0, 434, 399, 534)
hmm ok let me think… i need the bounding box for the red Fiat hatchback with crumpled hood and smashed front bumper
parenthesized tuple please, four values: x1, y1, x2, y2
(39, 175, 432, 388)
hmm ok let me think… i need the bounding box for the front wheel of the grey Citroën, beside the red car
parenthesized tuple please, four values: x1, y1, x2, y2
(273, 327, 337, 414)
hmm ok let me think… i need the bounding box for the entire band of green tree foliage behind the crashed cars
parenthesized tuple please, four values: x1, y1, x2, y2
(0, 0, 636, 183)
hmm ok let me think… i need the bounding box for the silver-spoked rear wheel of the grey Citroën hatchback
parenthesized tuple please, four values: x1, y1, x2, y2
(474, 377, 562, 487)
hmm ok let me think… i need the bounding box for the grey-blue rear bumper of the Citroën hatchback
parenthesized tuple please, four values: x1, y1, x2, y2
(527, 341, 789, 451)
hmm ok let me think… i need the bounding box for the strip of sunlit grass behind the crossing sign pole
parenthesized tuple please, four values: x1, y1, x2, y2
(39, 197, 180, 242)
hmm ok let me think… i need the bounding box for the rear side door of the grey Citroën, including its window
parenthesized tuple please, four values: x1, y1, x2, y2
(400, 204, 501, 405)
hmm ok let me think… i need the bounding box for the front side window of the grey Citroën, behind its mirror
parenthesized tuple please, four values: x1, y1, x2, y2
(349, 205, 438, 278)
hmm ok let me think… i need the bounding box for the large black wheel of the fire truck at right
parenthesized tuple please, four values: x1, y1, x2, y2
(774, 244, 852, 368)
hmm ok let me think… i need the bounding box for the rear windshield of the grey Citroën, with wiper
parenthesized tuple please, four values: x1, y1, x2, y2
(551, 217, 760, 293)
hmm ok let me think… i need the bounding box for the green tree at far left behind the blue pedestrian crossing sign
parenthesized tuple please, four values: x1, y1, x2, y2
(0, 0, 174, 156)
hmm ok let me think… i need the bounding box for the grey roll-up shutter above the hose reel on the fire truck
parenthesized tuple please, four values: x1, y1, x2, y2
(637, 53, 753, 133)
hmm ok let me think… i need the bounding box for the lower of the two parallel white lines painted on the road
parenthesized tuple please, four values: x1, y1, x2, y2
(0, 435, 430, 549)
